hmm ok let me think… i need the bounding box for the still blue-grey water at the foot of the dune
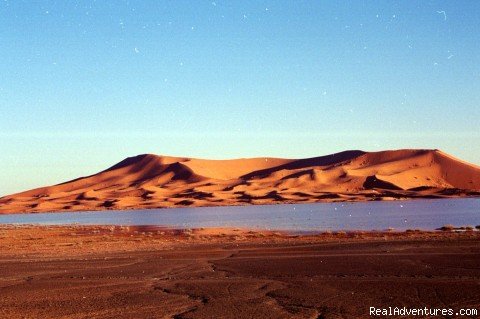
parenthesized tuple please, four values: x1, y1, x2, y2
(0, 198, 480, 231)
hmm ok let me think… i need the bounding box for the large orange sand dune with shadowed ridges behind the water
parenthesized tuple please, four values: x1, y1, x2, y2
(0, 150, 480, 213)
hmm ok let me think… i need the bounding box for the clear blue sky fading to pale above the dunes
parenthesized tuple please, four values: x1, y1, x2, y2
(0, 0, 480, 195)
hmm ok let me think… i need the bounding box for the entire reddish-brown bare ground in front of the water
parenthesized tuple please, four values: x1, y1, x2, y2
(0, 226, 480, 318)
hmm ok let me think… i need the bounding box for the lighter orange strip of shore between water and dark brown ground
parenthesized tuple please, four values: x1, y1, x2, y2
(0, 224, 480, 255)
